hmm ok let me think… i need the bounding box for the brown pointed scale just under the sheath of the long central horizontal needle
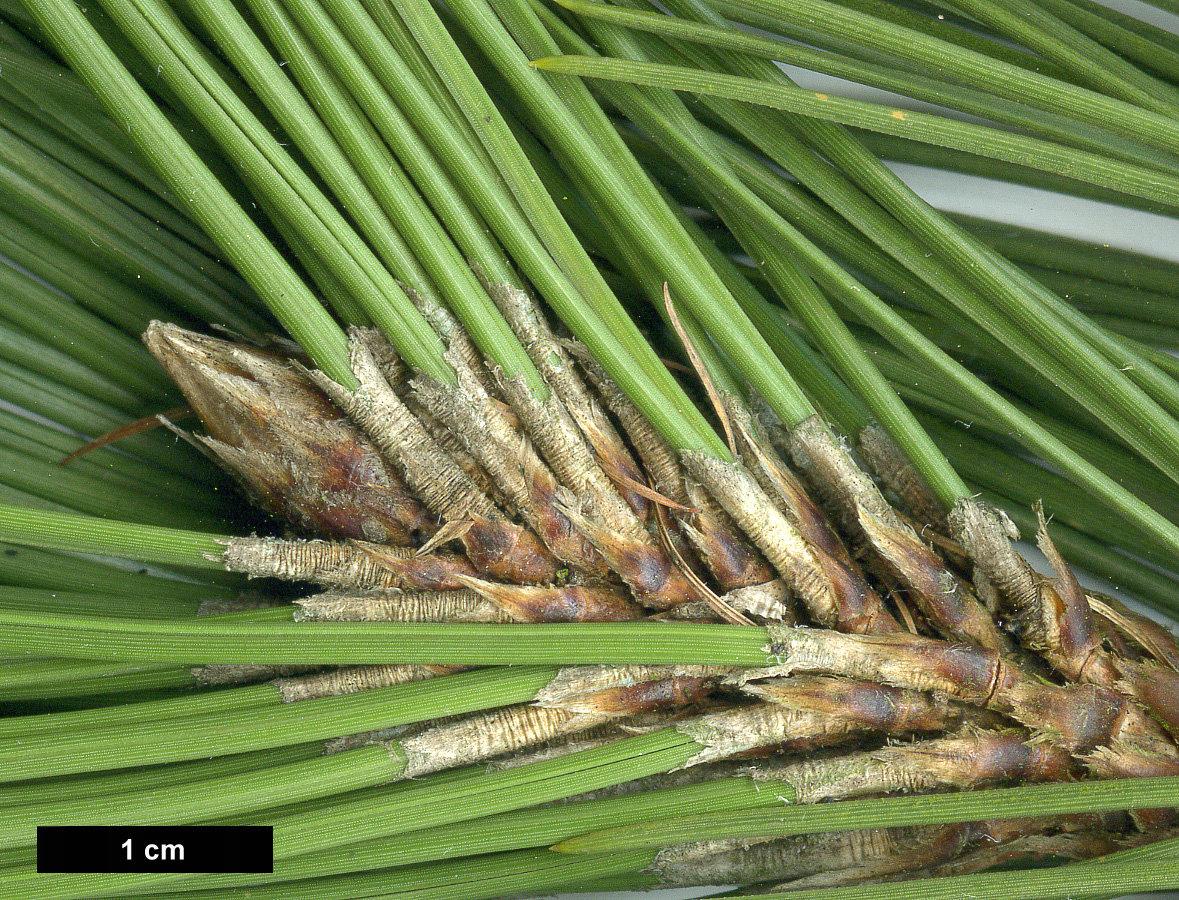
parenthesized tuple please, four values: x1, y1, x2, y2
(742, 675, 974, 734)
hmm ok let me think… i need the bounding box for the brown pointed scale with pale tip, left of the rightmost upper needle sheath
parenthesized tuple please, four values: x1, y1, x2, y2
(859, 511, 1014, 656)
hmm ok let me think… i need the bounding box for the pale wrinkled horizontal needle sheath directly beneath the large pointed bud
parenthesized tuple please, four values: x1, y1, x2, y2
(222, 538, 475, 591)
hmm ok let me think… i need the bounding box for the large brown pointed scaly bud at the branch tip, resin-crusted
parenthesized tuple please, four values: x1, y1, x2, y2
(144, 322, 434, 545)
